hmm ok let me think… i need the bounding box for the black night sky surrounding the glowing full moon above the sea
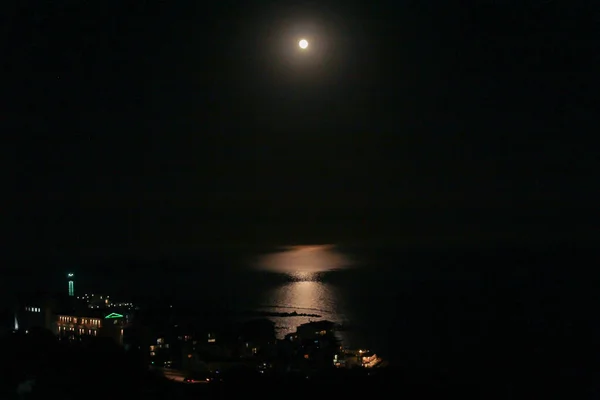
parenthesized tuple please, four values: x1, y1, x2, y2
(2, 0, 600, 258)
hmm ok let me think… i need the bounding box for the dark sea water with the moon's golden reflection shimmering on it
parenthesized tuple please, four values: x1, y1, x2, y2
(9, 246, 600, 367)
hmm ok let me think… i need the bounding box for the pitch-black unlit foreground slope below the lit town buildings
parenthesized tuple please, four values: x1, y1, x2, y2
(0, 331, 597, 399)
